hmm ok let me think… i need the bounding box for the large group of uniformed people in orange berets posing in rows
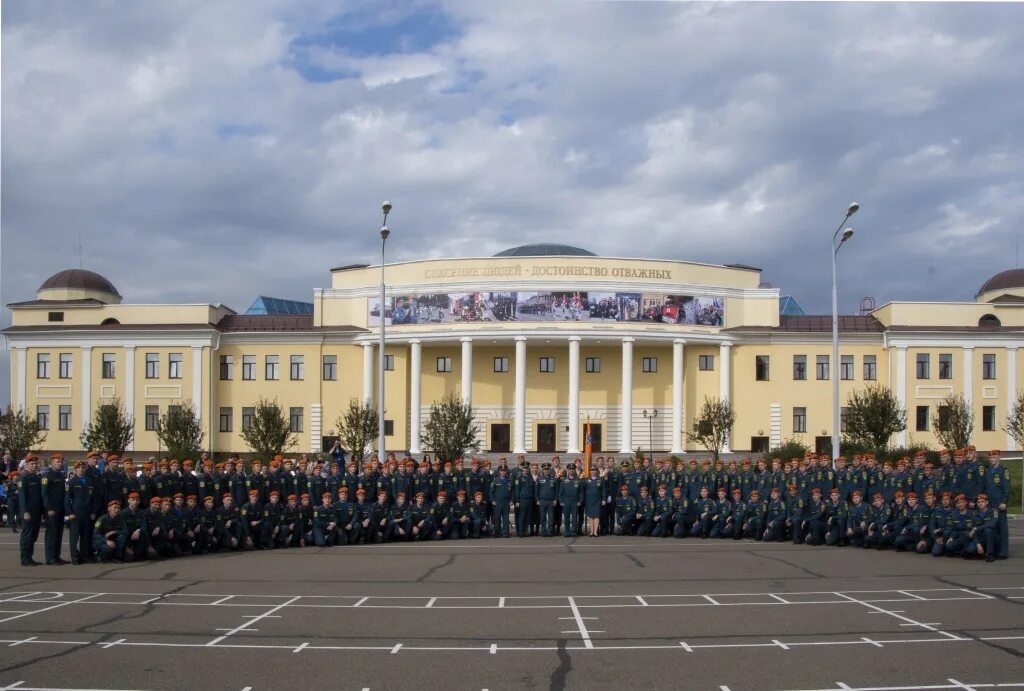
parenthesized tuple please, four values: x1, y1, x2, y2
(8, 447, 1011, 566)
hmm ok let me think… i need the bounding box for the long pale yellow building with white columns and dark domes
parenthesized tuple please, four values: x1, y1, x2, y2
(4, 245, 1024, 452)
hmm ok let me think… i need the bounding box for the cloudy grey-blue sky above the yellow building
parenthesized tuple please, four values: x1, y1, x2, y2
(0, 0, 1024, 401)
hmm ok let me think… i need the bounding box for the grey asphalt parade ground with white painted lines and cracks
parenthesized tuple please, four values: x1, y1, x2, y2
(0, 520, 1024, 691)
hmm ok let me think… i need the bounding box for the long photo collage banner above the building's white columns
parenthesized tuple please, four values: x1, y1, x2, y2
(369, 291, 725, 327)
